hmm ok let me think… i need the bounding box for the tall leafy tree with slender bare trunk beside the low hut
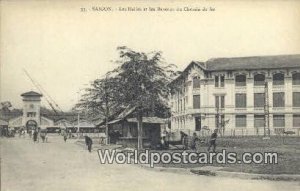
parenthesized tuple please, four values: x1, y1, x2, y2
(115, 47, 174, 149)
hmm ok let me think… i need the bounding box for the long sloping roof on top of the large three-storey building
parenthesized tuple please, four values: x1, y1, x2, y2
(204, 54, 300, 71)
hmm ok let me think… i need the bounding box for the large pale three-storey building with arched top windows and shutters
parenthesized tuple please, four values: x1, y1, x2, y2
(170, 55, 300, 135)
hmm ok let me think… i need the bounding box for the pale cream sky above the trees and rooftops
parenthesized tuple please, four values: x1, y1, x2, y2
(0, 0, 300, 111)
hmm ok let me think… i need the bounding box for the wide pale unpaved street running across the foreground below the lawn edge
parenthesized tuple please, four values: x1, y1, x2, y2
(0, 137, 300, 191)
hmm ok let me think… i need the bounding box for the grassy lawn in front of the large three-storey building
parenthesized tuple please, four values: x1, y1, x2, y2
(156, 137, 300, 174)
